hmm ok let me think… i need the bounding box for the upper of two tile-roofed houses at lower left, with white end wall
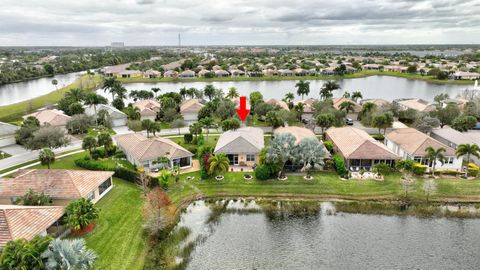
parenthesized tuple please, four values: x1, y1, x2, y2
(0, 169, 113, 206)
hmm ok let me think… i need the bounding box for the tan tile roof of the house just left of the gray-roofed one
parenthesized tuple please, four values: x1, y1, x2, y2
(115, 133, 193, 162)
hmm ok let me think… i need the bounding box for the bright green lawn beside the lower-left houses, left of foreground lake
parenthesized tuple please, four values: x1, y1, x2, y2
(84, 178, 147, 270)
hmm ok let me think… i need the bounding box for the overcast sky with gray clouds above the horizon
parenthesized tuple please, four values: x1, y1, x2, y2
(0, 0, 480, 46)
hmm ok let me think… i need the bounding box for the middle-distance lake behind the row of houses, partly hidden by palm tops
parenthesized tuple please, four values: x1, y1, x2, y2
(107, 76, 473, 101)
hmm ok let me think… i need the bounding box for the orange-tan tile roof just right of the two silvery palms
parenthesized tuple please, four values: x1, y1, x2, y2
(327, 127, 400, 159)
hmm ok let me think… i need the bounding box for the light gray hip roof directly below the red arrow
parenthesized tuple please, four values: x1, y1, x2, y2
(214, 127, 265, 154)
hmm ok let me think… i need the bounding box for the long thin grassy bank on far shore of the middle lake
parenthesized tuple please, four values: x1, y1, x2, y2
(118, 70, 473, 85)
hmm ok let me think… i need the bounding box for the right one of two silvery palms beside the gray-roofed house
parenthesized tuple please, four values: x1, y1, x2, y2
(297, 138, 325, 176)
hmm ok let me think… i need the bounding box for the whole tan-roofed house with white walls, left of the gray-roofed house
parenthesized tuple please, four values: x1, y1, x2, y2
(115, 133, 193, 171)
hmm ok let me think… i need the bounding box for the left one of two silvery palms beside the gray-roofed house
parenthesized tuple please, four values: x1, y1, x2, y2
(267, 133, 297, 177)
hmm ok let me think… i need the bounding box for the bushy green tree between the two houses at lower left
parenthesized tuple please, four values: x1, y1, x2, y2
(65, 198, 99, 231)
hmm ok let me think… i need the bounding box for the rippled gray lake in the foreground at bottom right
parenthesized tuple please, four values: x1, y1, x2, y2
(178, 201, 480, 269)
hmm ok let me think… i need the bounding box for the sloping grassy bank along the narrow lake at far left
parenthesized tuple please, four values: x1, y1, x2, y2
(0, 75, 102, 122)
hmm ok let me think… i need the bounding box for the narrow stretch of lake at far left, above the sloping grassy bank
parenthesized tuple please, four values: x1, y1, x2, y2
(0, 71, 85, 106)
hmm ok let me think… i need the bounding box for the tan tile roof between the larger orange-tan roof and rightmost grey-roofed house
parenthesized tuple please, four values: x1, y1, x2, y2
(385, 128, 455, 156)
